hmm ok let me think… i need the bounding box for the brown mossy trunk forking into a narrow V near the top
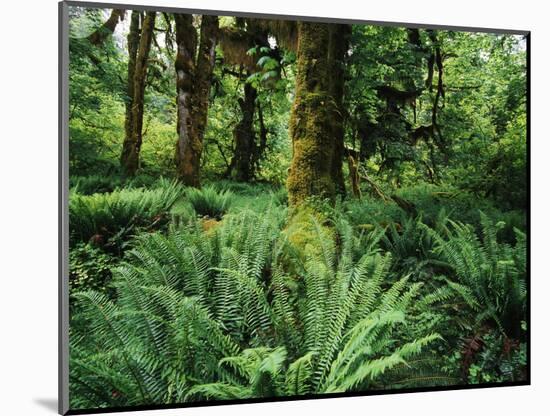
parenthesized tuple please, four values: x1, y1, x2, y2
(175, 14, 218, 187)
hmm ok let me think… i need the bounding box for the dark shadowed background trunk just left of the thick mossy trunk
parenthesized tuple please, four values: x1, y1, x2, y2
(231, 82, 258, 182)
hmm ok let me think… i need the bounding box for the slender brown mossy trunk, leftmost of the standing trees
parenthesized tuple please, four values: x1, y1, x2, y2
(120, 12, 156, 176)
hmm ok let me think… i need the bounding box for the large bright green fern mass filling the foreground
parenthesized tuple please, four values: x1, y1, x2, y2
(70, 207, 448, 408)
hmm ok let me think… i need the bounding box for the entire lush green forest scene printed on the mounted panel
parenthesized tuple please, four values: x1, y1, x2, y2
(69, 5, 528, 410)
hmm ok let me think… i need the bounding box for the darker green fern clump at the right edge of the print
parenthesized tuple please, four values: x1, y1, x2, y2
(427, 212, 527, 339)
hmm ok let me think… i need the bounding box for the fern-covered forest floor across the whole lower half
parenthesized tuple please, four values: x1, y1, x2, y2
(70, 178, 526, 408)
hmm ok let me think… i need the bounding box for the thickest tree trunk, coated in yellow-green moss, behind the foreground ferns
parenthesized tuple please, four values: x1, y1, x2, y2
(287, 22, 347, 206)
